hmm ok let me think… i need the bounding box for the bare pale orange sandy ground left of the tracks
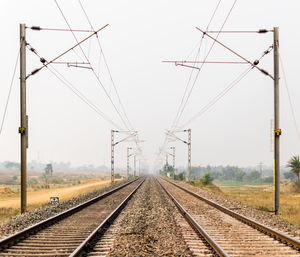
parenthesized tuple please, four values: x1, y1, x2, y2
(0, 180, 116, 208)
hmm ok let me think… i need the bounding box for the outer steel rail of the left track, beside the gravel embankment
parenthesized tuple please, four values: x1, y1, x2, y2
(0, 178, 138, 250)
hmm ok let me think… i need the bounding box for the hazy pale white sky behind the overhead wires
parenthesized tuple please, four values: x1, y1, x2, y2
(0, 0, 300, 171)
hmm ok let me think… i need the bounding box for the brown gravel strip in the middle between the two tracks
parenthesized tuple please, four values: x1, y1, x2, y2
(107, 177, 193, 257)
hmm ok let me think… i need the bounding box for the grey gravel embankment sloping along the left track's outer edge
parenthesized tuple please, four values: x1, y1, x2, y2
(0, 181, 132, 238)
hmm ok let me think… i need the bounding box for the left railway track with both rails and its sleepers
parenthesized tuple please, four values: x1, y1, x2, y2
(0, 178, 144, 257)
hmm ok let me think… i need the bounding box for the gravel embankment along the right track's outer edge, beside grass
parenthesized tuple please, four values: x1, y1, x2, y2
(171, 178, 300, 240)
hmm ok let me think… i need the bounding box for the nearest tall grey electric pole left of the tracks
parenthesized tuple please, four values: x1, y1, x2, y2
(19, 24, 28, 213)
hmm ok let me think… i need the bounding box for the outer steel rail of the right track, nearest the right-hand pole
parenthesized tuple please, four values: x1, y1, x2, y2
(162, 178, 300, 250)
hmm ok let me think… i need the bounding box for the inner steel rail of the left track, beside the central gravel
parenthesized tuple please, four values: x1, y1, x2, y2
(69, 178, 145, 257)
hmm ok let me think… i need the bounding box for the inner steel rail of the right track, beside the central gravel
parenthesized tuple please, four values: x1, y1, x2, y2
(156, 179, 229, 257)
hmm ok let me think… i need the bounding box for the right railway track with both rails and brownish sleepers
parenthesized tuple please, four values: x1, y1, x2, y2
(158, 178, 300, 257)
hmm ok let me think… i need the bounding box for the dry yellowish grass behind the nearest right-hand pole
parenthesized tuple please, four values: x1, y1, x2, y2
(221, 184, 300, 227)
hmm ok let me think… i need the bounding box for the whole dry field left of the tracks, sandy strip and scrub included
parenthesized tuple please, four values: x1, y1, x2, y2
(0, 169, 123, 221)
